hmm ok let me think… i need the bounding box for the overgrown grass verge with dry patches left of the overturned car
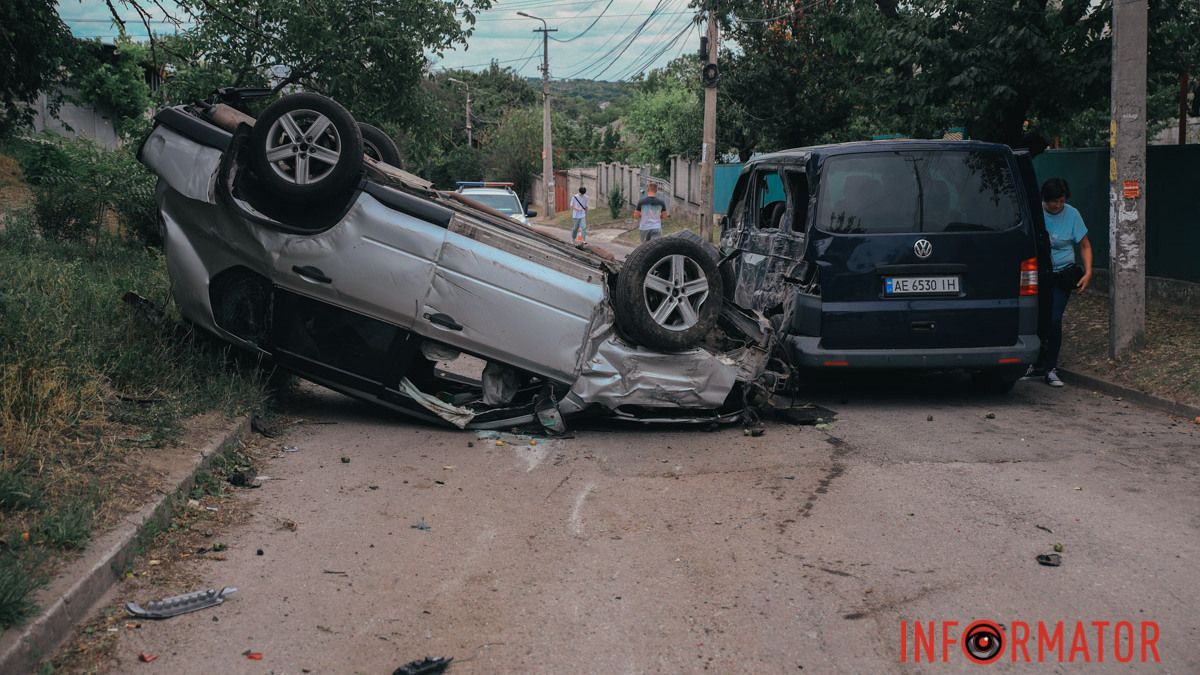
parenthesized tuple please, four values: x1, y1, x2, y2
(0, 216, 264, 628)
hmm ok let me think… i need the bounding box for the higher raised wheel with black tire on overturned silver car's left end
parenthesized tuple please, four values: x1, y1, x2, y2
(251, 94, 362, 202)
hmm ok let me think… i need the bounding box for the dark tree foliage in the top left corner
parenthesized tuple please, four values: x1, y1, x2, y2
(0, 0, 74, 137)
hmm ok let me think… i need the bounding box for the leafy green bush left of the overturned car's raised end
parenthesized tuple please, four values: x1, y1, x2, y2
(10, 135, 162, 246)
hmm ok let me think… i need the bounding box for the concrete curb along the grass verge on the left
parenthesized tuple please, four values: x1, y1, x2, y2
(0, 417, 250, 673)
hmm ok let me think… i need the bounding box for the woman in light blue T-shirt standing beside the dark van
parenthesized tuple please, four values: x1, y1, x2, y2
(1027, 178, 1092, 387)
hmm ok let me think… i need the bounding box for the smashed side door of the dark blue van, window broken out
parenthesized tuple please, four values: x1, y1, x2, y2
(734, 167, 809, 315)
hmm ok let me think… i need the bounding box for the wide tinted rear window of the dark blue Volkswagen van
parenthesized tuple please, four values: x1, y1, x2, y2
(816, 150, 1021, 234)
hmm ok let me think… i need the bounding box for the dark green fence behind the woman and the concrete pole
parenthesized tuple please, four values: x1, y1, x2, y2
(1033, 144, 1200, 282)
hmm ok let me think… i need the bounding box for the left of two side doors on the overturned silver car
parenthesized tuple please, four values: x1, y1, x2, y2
(275, 184, 451, 329)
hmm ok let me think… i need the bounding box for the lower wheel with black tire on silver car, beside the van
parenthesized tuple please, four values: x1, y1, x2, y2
(613, 237, 725, 351)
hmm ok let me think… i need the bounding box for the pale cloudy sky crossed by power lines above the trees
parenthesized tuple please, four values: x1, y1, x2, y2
(59, 0, 702, 80)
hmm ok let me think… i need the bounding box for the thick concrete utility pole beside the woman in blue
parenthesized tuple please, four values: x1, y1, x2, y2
(1109, 0, 1147, 358)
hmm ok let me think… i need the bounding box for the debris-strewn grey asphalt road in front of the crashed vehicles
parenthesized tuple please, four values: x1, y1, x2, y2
(87, 376, 1200, 673)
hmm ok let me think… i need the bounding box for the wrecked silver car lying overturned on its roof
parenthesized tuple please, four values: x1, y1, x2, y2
(139, 94, 786, 431)
